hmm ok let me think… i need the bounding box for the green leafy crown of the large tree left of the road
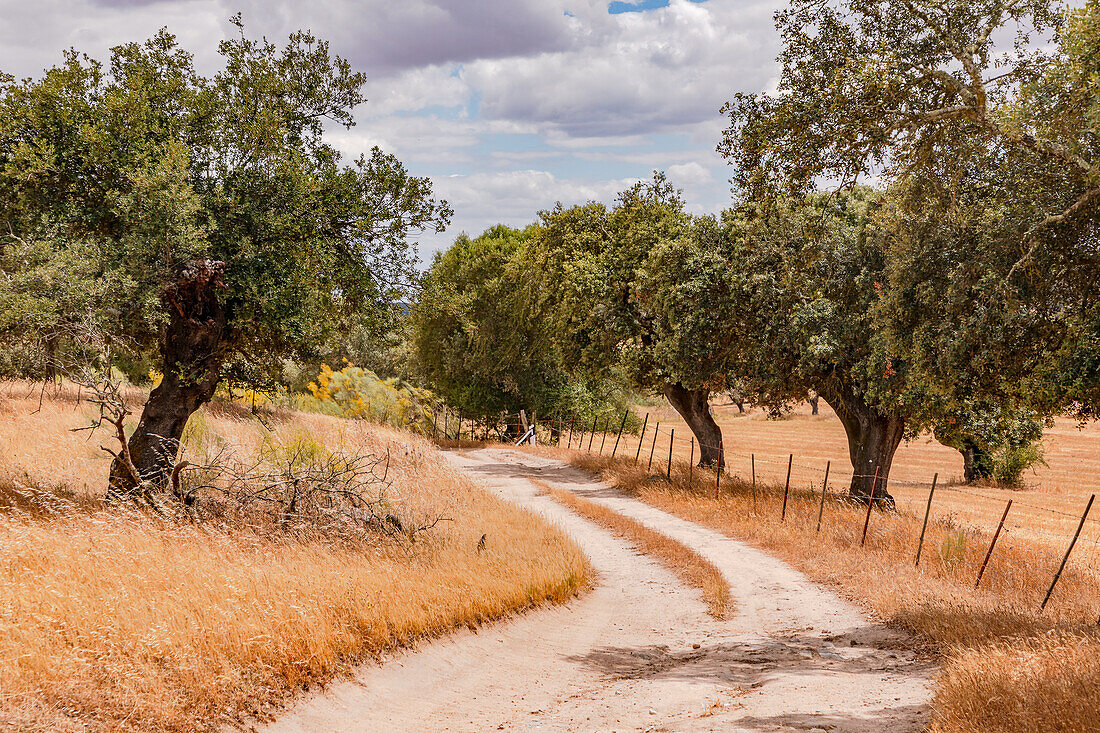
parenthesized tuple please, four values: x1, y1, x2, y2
(0, 19, 450, 381)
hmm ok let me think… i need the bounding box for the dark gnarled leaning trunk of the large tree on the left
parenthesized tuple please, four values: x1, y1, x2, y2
(109, 260, 228, 496)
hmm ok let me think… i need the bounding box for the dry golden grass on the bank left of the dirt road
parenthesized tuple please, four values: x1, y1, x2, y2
(0, 384, 591, 731)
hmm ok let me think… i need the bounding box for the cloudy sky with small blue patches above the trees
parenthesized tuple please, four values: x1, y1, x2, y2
(0, 0, 780, 263)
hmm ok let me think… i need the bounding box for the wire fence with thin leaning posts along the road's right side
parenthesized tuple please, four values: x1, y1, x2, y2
(422, 402, 1100, 608)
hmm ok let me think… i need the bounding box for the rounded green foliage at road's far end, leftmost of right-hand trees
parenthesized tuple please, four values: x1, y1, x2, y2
(413, 226, 625, 419)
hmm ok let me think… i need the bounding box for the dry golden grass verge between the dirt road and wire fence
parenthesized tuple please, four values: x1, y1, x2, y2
(571, 452, 1100, 733)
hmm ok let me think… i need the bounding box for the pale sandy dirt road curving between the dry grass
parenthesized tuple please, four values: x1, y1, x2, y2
(263, 449, 932, 733)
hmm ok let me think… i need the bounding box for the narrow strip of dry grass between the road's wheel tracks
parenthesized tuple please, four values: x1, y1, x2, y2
(531, 479, 733, 620)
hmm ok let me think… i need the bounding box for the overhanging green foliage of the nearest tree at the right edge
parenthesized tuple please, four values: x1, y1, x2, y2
(721, 0, 1100, 415)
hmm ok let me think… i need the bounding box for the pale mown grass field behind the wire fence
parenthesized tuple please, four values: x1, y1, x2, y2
(567, 400, 1100, 559)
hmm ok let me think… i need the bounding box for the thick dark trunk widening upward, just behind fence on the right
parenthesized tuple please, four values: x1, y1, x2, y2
(817, 389, 905, 506)
